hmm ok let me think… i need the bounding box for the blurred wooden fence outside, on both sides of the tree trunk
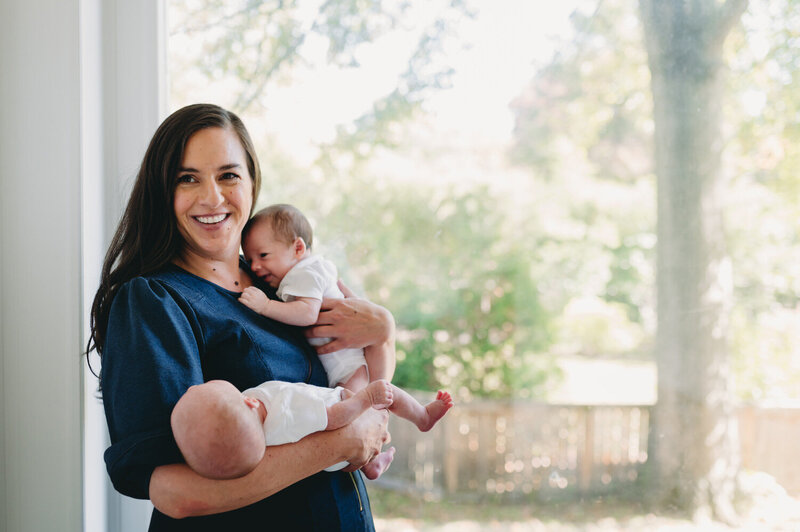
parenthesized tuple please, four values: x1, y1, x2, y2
(378, 394, 800, 499)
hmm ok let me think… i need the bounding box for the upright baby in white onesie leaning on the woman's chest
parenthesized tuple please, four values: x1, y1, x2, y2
(239, 204, 453, 474)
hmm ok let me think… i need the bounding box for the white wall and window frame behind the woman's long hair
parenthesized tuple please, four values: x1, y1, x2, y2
(0, 0, 165, 532)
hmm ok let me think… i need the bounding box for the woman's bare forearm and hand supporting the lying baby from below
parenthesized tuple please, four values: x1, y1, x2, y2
(150, 408, 390, 519)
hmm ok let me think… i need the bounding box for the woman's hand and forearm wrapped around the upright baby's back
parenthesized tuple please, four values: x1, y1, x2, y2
(306, 281, 395, 380)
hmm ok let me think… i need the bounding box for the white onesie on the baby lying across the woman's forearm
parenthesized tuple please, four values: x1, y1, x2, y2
(243, 381, 348, 471)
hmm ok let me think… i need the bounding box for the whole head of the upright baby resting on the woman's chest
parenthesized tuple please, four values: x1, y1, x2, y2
(242, 204, 313, 288)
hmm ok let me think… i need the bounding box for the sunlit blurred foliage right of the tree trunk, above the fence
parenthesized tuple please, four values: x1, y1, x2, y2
(725, 0, 800, 400)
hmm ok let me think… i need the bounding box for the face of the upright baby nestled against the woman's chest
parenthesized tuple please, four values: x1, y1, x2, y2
(242, 222, 305, 288)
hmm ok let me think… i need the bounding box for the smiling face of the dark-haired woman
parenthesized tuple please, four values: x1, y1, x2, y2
(174, 127, 253, 260)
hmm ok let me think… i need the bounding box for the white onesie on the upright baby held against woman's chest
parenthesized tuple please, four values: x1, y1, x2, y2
(277, 255, 367, 386)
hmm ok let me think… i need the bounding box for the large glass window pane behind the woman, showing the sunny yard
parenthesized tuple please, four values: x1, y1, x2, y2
(168, 0, 800, 530)
